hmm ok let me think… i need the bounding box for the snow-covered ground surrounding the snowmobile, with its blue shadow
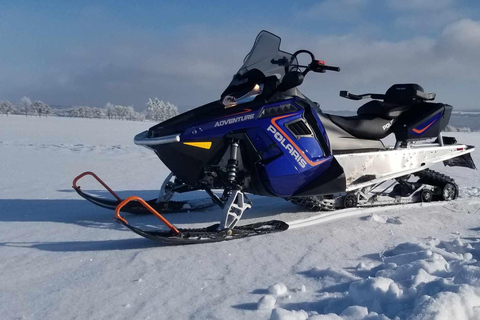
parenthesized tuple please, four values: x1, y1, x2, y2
(0, 116, 480, 320)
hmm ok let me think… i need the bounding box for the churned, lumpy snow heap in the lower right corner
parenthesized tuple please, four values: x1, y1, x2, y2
(258, 238, 480, 320)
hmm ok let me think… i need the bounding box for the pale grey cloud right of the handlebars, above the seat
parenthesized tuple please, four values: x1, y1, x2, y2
(294, 19, 480, 109)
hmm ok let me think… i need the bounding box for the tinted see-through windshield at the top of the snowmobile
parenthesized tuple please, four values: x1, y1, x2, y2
(238, 30, 297, 81)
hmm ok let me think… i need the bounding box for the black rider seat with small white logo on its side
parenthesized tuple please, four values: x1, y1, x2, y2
(328, 115, 394, 140)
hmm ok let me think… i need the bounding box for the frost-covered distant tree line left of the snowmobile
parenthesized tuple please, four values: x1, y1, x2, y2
(0, 97, 178, 121)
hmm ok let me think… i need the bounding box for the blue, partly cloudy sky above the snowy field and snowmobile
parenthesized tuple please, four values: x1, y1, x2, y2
(0, 0, 480, 110)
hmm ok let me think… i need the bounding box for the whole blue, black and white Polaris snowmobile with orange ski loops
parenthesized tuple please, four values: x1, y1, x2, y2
(73, 31, 475, 244)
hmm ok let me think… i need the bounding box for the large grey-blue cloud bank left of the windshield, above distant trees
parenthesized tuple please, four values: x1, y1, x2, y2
(0, 27, 255, 109)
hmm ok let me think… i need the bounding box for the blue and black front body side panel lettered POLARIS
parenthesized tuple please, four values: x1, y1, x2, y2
(152, 99, 344, 197)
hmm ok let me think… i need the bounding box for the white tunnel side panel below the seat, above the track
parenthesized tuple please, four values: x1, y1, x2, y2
(335, 145, 475, 192)
